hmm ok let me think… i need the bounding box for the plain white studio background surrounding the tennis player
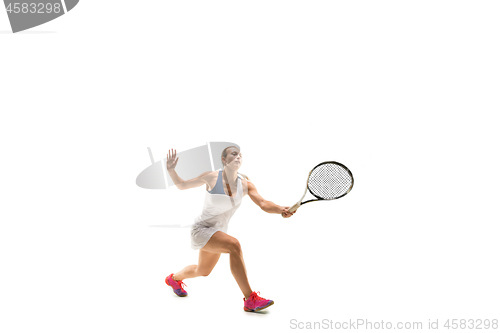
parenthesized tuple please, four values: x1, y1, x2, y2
(0, 0, 500, 332)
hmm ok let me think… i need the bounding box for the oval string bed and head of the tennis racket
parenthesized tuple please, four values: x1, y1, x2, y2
(308, 163, 353, 200)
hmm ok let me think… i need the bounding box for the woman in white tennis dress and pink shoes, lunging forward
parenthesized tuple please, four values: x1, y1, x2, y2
(165, 146, 293, 311)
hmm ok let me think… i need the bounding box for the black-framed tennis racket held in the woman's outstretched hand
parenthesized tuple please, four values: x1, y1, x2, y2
(288, 162, 354, 213)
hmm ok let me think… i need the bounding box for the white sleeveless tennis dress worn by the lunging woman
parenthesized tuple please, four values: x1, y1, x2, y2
(191, 170, 243, 250)
